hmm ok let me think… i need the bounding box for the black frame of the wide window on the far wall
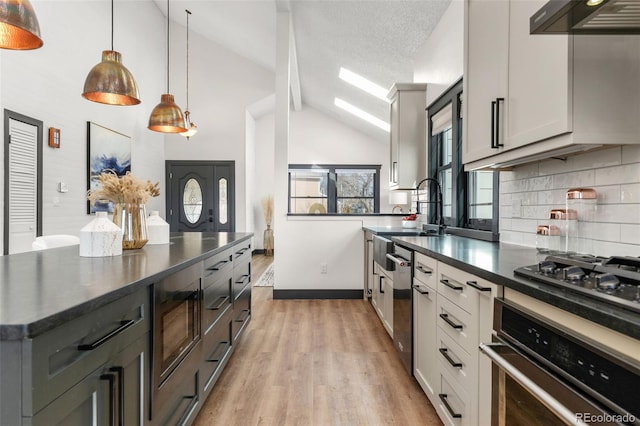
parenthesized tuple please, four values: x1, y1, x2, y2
(287, 164, 382, 216)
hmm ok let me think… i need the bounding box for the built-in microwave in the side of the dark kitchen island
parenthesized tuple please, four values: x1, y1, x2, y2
(153, 264, 202, 389)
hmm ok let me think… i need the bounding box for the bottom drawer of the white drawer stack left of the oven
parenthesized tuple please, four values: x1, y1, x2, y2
(436, 371, 477, 426)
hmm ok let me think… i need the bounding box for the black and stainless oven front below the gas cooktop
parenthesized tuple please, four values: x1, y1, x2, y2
(480, 299, 640, 425)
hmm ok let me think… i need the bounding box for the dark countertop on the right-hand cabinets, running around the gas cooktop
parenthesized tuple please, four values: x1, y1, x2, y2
(391, 235, 640, 339)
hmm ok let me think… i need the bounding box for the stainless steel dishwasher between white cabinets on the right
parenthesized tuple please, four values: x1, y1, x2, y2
(387, 245, 413, 375)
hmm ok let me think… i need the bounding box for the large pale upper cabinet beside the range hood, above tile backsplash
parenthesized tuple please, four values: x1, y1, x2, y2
(463, 0, 640, 170)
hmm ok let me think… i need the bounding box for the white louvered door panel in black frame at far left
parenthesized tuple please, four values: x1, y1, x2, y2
(5, 119, 38, 254)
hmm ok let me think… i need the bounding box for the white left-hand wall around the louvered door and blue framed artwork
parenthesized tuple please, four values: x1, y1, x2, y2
(0, 1, 166, 255)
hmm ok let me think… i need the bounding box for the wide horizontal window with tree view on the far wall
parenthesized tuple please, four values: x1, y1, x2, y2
(289, 164, 380, 214)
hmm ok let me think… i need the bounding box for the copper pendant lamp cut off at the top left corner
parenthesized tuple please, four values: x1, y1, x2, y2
(0, 0, 42, 50)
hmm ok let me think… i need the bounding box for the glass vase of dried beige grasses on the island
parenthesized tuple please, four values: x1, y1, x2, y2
(88, 170, 160, 250)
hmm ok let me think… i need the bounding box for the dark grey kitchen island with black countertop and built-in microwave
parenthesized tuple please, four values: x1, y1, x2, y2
(0, 233, 253, 425)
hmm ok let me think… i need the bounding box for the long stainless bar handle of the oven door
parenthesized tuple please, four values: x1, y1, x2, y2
(480, 343, 586, 426)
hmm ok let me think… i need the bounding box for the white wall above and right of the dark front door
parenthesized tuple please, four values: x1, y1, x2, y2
(162, 17, 274, 231)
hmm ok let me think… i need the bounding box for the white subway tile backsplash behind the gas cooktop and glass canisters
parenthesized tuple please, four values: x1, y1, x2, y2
(500, 145, 640, 256)
